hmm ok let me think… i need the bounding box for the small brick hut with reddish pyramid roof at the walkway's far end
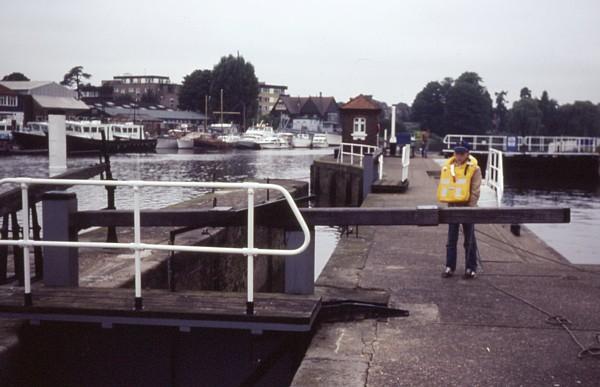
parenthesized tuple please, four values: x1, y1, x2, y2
(340, 94, 381, 146)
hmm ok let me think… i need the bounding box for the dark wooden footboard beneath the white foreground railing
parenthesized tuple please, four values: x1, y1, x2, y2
(0, 286, 321, 326)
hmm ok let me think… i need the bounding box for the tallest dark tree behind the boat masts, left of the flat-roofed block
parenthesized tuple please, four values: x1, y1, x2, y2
(210, 55, 258, 122)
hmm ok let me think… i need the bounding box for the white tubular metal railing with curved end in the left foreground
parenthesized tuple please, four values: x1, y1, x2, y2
(0, 177, 310, 312)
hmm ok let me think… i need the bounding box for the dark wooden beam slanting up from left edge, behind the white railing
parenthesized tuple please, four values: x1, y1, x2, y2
(0, 163, 106, 216)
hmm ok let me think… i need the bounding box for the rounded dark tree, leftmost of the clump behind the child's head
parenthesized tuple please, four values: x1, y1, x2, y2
(411, 82, 446, 135)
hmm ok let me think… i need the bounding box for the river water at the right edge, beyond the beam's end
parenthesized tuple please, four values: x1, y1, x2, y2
(503, 177, 600, 264)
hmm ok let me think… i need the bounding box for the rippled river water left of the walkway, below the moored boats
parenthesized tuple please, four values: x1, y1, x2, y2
(0, 149, 339, 277)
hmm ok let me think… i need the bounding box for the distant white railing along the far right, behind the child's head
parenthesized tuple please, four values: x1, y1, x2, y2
(443, 134, 600, 154)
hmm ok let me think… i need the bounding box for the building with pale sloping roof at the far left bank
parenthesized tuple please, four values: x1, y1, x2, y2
(0, 81, 89, 127)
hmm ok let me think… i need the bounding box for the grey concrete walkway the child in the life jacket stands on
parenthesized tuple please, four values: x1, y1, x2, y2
(292, 158, 600, 386)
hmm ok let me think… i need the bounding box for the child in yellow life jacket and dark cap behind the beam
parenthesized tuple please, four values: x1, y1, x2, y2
(437, 141, 481, 279)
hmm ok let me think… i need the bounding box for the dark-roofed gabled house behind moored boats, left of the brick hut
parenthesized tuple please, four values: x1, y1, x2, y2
(271, 95, 339, 132)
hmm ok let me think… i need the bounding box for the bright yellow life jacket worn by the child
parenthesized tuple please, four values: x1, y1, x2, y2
(437, 155, 478, 203)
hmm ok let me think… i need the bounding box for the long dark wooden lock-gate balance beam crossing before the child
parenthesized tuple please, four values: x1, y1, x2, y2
(72, 208, 570, 229)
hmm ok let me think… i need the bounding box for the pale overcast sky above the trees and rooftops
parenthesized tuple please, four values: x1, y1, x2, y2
(0, 0, 600, 103)
